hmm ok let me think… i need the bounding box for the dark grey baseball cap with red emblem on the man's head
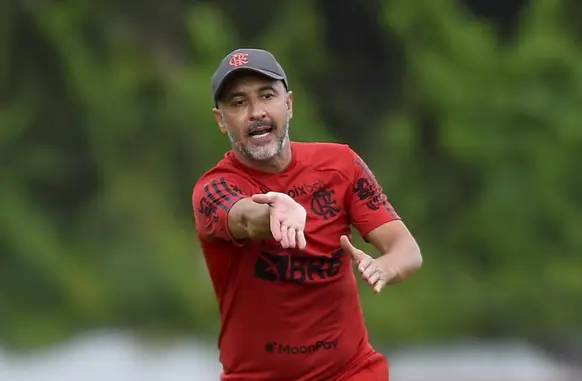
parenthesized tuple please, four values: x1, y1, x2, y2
(212, 49, 288, 104)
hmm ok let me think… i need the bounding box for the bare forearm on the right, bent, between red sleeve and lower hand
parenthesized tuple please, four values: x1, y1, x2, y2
(376, 236, 422, 284)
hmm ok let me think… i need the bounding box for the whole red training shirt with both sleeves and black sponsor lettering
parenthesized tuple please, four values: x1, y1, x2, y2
(192, 142, 399, 381)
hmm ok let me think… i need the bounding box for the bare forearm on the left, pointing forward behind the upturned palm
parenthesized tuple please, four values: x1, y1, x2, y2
(228, 198, 271, 240)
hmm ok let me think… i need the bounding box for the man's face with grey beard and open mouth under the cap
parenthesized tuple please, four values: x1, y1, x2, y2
(213, 72, 293, 161)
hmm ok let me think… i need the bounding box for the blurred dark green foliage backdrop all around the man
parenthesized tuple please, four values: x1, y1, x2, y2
(0, 0, 582, 360)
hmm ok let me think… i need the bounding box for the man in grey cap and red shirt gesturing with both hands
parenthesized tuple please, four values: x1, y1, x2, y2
(192, 49, 422, 381)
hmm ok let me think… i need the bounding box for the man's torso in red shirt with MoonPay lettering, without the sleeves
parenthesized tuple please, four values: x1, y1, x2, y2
(202, 143, 384, 381)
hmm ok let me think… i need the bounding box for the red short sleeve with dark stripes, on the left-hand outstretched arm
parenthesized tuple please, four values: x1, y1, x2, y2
(192, 174, 249, 244)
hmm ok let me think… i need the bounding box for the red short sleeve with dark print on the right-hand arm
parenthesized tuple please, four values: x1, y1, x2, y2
(349, 149, 400, 237)
